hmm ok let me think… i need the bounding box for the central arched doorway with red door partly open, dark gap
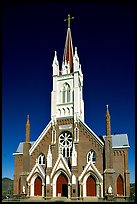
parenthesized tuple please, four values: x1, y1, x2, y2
(56, 174, 68, 197)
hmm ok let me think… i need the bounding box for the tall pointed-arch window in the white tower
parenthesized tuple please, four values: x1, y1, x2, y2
(62, 83, 71, 103)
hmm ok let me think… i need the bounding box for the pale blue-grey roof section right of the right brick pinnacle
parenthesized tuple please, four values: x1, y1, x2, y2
(103, 134, 130, 148)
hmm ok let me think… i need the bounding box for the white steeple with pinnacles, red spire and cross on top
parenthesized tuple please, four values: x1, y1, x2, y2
(51, 15, 84, 122)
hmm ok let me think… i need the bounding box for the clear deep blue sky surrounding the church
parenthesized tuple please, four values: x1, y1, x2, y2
(2, 3, 135, 183)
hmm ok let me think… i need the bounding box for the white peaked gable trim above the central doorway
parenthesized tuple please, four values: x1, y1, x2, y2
(50, 154, 71, 178)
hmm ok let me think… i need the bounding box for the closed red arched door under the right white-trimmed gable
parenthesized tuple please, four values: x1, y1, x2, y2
(86, 176, 96, 196)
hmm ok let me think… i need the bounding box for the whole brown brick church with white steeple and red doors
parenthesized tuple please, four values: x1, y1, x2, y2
(13, 15, 130, 200)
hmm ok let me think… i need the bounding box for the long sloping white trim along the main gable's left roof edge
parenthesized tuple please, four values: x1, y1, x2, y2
(29, 121, 51, 155)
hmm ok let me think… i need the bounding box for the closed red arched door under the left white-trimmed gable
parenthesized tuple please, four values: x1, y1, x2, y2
(34, 176, 42, 196)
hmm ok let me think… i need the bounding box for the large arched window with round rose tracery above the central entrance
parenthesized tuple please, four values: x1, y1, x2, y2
(59, 131, 72, 157)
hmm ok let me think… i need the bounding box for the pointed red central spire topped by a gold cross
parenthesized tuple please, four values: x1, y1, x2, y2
(62, 14, 74, 74)
